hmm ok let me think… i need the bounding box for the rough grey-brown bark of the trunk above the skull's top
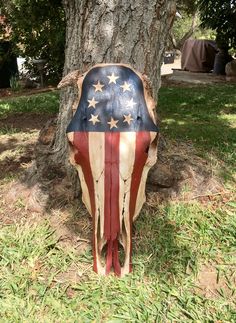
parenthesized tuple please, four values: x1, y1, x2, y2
(63, 0, 175, 97)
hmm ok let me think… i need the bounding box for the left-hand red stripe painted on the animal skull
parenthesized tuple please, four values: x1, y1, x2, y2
(73, 132, 97, 272)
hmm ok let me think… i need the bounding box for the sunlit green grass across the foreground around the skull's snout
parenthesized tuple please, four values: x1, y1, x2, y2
(0, 203, 236, 322)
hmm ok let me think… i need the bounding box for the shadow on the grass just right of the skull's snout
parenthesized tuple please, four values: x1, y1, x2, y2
(133, 207, 197, 280)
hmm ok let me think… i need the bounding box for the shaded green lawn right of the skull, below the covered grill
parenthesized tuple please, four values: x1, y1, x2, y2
(158, 85, 236, 179)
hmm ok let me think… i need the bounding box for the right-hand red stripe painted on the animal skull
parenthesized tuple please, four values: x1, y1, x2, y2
(129, 131, 151, 271)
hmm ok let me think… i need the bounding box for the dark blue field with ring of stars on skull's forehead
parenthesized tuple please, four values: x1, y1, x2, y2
(67, 65, 158, 132)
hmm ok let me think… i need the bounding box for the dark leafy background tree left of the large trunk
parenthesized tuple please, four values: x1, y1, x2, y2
(0, 0, 65, 81)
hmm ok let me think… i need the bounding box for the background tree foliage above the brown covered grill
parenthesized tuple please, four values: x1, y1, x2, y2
(169, 0, 236, 50)
